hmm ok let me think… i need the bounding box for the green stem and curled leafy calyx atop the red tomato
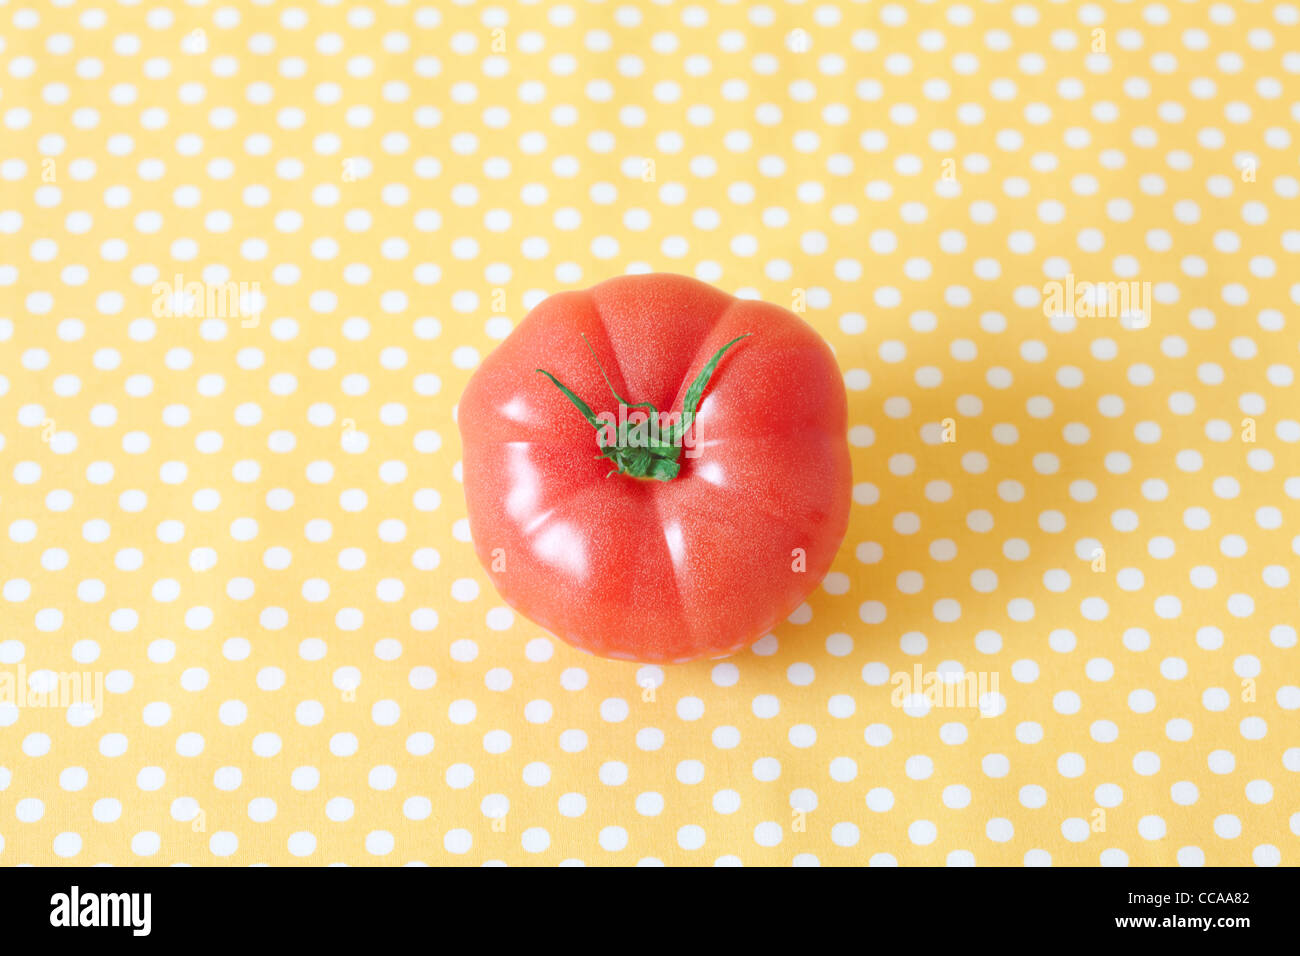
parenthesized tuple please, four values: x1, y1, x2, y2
(537, 332, 751, 481)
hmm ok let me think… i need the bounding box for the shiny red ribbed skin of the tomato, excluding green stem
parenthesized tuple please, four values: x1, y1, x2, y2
(458, 273, 852, 662)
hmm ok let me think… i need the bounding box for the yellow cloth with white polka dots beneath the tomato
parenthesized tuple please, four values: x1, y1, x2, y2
(0, 0, 1300, 865)
